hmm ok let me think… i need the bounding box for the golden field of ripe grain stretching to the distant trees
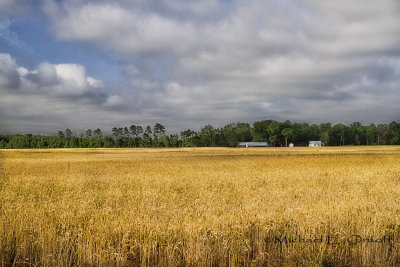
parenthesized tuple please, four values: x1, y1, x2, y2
(0, 146, 400, 266)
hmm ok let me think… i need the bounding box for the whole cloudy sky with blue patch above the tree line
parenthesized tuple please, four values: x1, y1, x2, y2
(0, 0, 400, 134)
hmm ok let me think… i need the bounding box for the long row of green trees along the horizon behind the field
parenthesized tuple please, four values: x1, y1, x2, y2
(0, 120, 400, 149)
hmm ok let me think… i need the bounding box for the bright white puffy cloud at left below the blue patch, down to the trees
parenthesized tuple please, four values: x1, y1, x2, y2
(0, 54, 128, 133)
